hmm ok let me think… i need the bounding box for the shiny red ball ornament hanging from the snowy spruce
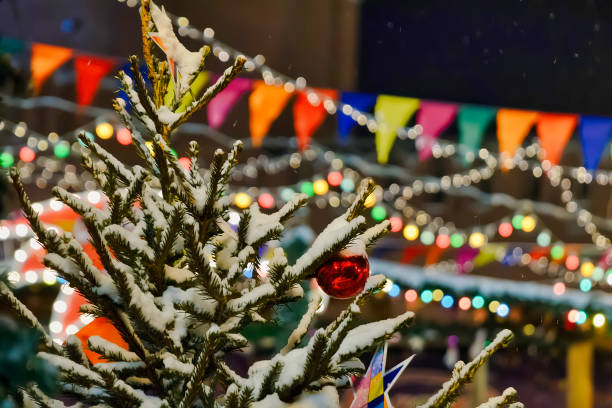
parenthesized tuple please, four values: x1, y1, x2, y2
(317, 255, 370, 299)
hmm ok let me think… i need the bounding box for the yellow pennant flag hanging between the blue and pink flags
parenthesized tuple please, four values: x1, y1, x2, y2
(374, 95, 419, 163)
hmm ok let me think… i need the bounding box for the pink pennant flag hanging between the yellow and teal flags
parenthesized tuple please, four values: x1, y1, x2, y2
(417, 101, 457, 161)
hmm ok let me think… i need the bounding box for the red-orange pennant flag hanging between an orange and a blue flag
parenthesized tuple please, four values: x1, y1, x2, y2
(293, 89, 338, 150)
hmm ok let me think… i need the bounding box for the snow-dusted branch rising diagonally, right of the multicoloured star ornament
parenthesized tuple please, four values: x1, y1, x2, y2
(419, 330, 514, 408)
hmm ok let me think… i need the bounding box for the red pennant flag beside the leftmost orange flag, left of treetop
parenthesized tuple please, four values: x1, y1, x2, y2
(74, 55, 115, 106)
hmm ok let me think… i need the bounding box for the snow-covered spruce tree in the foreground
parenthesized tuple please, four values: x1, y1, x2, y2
(0, 0, 516, 408)
